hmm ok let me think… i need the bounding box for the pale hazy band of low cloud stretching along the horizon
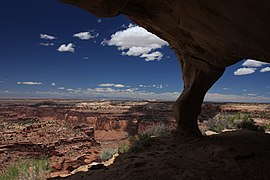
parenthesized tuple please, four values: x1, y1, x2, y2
(3, 87, 270, 103)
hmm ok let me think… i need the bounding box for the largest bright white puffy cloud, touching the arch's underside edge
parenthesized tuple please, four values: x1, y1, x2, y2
(102, 25, 168, 61)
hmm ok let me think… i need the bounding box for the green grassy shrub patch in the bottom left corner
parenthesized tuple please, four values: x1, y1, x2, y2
(0, 158, 50, 180)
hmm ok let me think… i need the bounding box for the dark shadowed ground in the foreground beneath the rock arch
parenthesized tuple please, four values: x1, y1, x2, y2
(51, 130, 270, 180)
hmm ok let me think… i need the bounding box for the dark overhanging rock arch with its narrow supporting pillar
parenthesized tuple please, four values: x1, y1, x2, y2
(61, 0, 270, 136)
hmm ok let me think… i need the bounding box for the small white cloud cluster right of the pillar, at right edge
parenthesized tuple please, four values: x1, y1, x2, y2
(234, 59, 270, 76)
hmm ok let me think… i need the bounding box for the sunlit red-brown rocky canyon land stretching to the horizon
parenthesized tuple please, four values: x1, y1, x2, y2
(0, 100, 270, 177)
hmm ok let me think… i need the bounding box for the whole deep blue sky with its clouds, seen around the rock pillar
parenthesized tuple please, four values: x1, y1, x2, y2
(0, 0, 270, 102)
